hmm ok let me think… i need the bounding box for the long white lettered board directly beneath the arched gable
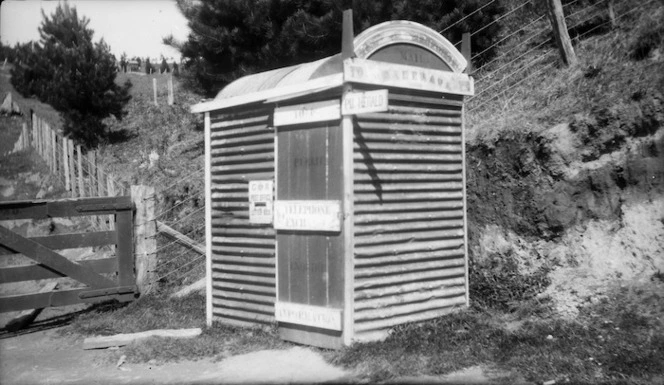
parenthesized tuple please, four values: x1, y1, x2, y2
(344, 59, 475, 95)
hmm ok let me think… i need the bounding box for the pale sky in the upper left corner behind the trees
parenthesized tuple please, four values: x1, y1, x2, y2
(0, 0, 189, 59)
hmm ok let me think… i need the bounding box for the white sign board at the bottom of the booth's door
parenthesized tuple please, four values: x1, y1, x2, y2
(274, 302, 342, 331)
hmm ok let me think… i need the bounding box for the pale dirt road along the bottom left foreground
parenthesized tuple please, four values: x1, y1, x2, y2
(0, 329, 351, 385)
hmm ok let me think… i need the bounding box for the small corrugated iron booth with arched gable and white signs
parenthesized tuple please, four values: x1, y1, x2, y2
(192, 21, 473, 348)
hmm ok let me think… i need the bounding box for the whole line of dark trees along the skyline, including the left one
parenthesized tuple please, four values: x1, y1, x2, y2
(0, 0, 520, 148)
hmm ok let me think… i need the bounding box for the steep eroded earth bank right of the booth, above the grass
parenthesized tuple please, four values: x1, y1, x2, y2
(467, 2, 664, 316)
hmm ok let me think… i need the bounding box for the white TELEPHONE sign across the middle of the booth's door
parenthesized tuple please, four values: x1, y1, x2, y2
(274, 200, 341, 231)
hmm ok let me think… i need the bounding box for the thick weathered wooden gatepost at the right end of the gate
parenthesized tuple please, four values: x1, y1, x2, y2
(131, 186, 157, 294)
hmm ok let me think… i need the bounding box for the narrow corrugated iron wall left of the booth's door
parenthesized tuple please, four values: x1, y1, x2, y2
(210, 106, 276, 326)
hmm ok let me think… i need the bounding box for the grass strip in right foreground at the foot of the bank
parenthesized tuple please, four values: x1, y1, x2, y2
(331, 296, 664, 384)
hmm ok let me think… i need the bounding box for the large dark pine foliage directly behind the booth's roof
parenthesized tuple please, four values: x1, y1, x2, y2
(164, 0, 502, 96)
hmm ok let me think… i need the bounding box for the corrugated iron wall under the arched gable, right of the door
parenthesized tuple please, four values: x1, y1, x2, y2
(354, 90, 466, 340)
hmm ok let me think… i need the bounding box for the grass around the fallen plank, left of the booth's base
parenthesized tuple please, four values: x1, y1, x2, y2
(63, 294, 290, 363)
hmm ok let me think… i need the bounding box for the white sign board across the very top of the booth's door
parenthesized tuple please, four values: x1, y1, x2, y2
(274, 100, 341, 126)
